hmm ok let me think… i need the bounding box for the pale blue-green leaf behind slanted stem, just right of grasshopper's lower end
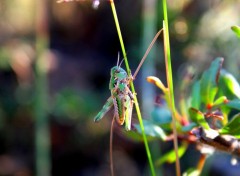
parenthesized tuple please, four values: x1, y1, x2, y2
(134, 120, 167, 140)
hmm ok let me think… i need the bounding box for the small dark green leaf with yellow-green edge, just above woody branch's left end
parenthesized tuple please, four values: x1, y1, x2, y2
(189, 108, 210, 129)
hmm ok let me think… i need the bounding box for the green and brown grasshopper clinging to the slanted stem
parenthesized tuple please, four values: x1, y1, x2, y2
(94, 55, 134, 131)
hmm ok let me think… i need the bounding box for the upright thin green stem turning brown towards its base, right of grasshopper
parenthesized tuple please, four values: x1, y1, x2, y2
(163, 0, 181, 176)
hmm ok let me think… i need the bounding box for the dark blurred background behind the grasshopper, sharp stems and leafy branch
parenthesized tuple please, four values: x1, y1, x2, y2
(0, 0, 240, 176)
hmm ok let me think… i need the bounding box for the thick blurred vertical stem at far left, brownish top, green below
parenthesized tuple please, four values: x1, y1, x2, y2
(35, 0, 51, 176)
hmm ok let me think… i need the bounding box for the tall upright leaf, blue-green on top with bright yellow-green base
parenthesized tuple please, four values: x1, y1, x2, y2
(200, 57, 223, 105)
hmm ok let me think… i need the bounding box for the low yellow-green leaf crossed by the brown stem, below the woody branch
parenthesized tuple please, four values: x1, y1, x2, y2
(155, 143, 188, 166)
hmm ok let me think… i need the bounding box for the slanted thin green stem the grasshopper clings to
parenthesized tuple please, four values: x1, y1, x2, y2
(110, 0, 156, 176)
